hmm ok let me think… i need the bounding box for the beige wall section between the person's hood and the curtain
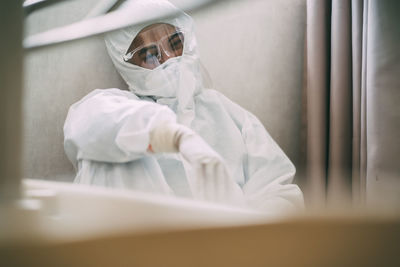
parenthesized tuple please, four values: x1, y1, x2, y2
(194, 0, 306, 172)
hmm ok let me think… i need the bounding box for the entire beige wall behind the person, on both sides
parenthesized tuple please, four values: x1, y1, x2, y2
(23, 0, 305, 181)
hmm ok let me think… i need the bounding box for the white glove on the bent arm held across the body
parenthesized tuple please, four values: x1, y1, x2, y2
(150, 123, 244, 205)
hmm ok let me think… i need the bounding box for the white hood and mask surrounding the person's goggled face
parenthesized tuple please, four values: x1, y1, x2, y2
(105, 0, 203, 101)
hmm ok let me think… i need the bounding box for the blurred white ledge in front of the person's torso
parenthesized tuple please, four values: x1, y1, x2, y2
(0, 179, 279, 245)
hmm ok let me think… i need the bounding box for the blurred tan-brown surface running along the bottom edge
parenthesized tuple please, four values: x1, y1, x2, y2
(0, 219, 400, 267)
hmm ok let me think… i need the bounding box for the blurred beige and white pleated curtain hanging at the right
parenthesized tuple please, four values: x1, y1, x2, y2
(302, 0, 400, 207)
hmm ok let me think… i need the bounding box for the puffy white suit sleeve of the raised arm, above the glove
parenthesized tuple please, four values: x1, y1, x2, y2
(64, 89, 176, 168)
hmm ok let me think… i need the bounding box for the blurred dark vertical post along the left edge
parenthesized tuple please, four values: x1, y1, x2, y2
(0, 0, 23, 202)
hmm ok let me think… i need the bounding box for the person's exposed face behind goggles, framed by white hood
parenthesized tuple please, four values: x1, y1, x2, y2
(124, 23, 184, 69)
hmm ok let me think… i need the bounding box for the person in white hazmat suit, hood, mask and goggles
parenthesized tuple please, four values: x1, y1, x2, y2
(64, 0, 303, 211)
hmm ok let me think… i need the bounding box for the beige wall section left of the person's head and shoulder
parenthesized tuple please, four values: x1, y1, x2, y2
(23, 0, 126, 181)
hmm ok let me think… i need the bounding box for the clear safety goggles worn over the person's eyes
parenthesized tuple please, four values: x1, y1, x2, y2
(123, 30, 185, 69)
